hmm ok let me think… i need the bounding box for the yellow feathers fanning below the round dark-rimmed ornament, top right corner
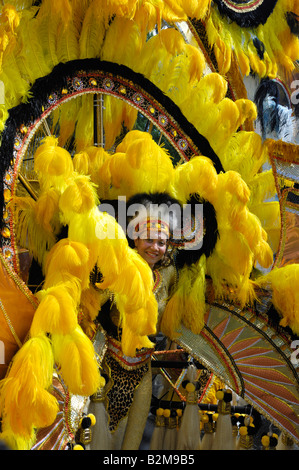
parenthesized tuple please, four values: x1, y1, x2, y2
(206, 0, 299, 78)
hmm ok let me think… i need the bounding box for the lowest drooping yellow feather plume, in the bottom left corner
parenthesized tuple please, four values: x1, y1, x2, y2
(0, 335, 58, 439)
